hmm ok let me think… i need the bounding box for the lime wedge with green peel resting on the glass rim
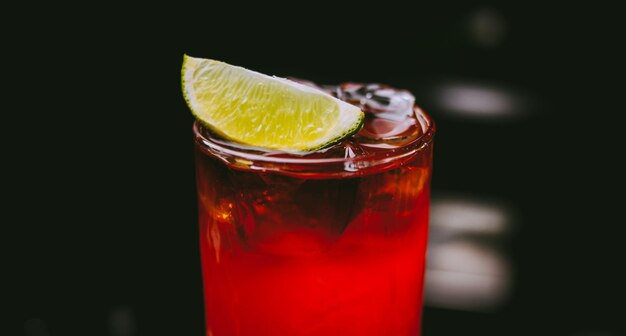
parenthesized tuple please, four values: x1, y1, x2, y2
(182, 55, 364, 152)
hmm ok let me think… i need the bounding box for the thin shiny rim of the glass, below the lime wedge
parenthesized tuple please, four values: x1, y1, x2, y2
(193, 106, 435, 166)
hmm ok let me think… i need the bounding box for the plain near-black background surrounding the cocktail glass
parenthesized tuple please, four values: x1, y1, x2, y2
(7, 1, 625, 336)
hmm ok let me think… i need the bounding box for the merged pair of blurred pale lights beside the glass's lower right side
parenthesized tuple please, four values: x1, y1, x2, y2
(425, 196, 513, 312)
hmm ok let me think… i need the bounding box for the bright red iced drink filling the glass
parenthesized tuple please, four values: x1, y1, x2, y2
(197, 82, 432, 336)
